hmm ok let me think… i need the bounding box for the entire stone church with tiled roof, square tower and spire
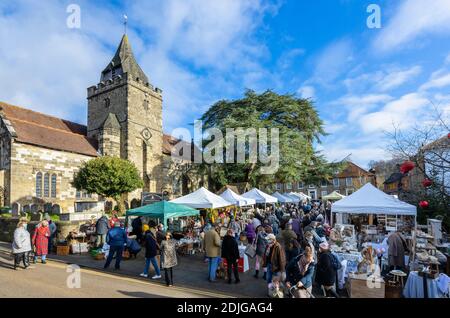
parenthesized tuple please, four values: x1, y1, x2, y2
(0, 35, 199, 219)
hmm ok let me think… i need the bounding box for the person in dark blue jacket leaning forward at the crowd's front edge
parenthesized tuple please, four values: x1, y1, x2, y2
(286, 246, 315, 298)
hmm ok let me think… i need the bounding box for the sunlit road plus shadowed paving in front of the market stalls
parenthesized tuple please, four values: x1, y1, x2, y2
(0, 242, 267, 298)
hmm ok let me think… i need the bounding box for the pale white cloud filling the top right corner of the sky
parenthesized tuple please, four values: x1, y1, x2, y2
(373, 0, 450, 52)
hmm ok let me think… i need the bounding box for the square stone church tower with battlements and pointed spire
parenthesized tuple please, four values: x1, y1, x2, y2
(87, 34, 163, 195)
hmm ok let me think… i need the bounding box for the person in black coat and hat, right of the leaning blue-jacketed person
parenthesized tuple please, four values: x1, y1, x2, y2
(316, 242, 339, 298)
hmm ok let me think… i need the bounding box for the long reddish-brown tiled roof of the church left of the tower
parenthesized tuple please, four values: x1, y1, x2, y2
(0, 102, 98, 156)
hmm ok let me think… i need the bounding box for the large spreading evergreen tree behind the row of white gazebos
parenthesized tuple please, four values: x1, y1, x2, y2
(201, 90, 339, 190)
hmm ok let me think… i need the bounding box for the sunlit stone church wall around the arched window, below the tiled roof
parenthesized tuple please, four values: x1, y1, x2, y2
(7, 142, 97, 212)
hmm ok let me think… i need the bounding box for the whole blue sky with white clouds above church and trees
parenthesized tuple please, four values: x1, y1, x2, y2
(0, 0, 450, 166)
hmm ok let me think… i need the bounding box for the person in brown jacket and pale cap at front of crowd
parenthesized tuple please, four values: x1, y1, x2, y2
(263, 233, 286, 284)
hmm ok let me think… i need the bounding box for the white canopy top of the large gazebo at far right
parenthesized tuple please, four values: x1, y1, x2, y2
(331, 183, 417, 227)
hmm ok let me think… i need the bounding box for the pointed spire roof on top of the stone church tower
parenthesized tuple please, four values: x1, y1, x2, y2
(100, 34, 149, 84)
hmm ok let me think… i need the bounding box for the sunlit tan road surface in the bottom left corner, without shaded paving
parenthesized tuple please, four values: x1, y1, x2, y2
(0, 250, 230, 298)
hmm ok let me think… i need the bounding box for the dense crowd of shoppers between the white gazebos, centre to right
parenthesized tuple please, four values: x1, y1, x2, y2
(200, 202, 339, 297)
